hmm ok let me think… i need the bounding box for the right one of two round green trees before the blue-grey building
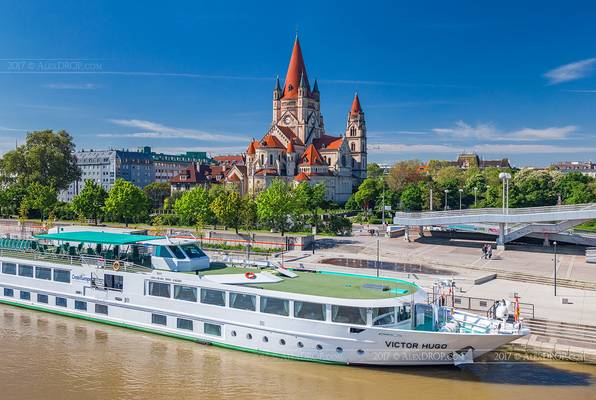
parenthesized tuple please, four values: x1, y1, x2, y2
(104, 178, 149, 226)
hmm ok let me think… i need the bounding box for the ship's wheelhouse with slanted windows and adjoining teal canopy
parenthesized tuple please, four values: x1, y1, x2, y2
(32, 231, 209, 272)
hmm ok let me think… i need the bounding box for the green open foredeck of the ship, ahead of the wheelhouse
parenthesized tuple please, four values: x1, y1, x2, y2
(200, 264, 419, 299)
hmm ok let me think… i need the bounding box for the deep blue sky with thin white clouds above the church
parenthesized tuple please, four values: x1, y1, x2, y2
(0, 0, 596, 167)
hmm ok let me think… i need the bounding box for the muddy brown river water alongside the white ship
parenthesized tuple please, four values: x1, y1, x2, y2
(0, 305, 596, 400)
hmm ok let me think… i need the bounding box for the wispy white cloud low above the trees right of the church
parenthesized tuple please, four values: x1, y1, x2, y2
(433, 121, 577, 141)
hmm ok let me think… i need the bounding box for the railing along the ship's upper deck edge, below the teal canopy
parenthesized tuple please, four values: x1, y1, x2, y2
(0, 248, 153, 273)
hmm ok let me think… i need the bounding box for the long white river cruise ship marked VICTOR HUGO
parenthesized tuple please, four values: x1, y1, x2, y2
(0, 231, 529, 365)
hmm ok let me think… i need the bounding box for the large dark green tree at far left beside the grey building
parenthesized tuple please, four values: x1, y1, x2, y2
(0, 130, 81, 190)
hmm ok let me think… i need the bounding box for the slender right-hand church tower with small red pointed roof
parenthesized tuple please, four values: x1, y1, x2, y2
(346, 93, 366, 180)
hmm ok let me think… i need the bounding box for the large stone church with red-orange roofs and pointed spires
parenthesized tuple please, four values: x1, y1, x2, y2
(226, 37, 367, 203)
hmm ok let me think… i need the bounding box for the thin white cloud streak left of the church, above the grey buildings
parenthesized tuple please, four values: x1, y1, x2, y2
(105, 119, 246, 141)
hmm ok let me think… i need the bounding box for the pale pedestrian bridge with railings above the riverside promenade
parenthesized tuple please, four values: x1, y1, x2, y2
(393, 203, 596, 245)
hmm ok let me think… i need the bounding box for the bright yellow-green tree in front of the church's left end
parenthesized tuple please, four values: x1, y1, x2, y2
(256, 179, 296, 236)
